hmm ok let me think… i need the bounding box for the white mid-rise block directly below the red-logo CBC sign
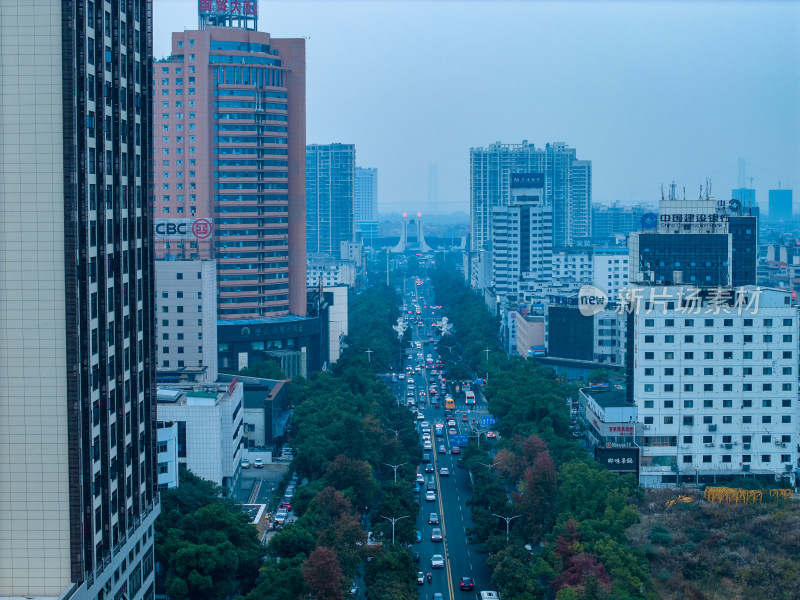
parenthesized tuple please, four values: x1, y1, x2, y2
(155, 260, 217, 382)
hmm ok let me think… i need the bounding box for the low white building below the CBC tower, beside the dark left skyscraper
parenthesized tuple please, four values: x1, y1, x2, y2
(158, 378, 244, 489)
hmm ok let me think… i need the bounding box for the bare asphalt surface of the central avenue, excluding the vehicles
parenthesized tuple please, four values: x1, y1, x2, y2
(394, 278, 493, 600)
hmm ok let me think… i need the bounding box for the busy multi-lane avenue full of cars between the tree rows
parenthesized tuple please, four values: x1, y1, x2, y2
(391, 278, 498, 600)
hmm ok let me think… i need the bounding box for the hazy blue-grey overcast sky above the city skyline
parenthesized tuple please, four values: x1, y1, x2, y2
(154, 0, 800, 213)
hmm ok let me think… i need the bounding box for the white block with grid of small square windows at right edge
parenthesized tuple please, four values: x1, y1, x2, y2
(627, 286, 798, 487)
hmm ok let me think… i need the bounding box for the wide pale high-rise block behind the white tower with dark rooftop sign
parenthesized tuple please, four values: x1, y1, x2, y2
(470, 140, 592, 252)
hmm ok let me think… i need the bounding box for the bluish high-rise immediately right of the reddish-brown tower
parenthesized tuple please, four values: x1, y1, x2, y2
(306, 144, 356, 254)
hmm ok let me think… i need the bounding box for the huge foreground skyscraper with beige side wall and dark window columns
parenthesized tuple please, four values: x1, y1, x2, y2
(0, 0, 159, 600)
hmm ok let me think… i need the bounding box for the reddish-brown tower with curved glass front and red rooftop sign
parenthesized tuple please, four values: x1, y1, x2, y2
(153, 11, 306, 321)
